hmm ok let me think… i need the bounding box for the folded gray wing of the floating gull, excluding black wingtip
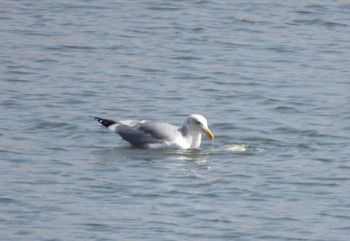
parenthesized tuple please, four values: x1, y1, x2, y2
(116, 121, 180, 146)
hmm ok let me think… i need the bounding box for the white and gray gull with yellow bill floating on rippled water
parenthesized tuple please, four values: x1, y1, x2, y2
(91, 114, 214, 149)
